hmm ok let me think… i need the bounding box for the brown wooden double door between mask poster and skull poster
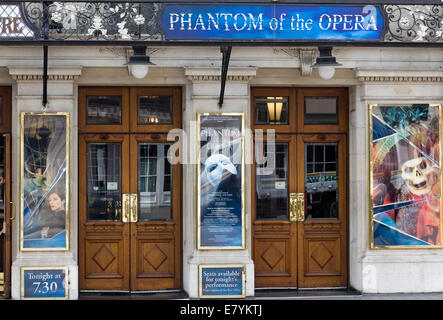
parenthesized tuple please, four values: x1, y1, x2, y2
(251, 88, 348, 288)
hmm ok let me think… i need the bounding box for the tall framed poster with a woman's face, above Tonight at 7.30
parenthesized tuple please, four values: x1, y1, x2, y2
(20, 112, 70, 251)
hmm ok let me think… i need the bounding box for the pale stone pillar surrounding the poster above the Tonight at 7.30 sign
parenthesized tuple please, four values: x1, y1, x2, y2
(9, 66, 81, 299)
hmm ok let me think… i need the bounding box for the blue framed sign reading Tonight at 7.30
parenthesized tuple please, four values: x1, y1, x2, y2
(21, 267, 68, 300)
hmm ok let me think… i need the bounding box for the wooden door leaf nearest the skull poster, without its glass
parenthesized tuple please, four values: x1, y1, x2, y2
(297, 134, 347, 288)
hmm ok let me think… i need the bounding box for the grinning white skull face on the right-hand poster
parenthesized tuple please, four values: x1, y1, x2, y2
(401, 157, 438, 195)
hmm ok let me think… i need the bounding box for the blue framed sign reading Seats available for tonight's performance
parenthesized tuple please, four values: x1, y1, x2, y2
(198, 264, 246, 298)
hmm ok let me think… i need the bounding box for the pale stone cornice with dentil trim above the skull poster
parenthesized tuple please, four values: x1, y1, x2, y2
(356, 69, 443, 83)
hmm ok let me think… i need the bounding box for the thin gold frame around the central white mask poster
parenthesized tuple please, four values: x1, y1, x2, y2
(195, 112, 246, 250)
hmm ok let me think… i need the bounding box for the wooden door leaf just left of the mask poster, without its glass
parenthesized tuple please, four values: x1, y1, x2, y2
(131, 134, 181, 291)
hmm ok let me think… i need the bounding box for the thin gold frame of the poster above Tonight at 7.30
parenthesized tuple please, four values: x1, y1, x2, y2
(19, 111, 71, 251)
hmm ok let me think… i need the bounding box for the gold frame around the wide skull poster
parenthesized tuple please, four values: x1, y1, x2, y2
(367, 103, 443, 250)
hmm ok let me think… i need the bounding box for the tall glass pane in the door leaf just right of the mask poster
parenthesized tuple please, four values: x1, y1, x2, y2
(255, 143, 288, 220)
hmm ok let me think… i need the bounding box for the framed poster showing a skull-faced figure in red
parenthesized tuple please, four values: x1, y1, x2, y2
(369, 104, 442, 248)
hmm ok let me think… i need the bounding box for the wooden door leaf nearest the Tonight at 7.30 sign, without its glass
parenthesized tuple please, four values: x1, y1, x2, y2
(79, 134, 130, 291)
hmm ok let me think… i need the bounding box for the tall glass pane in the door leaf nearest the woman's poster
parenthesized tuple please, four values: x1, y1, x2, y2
(87, 143, 122, 221)
